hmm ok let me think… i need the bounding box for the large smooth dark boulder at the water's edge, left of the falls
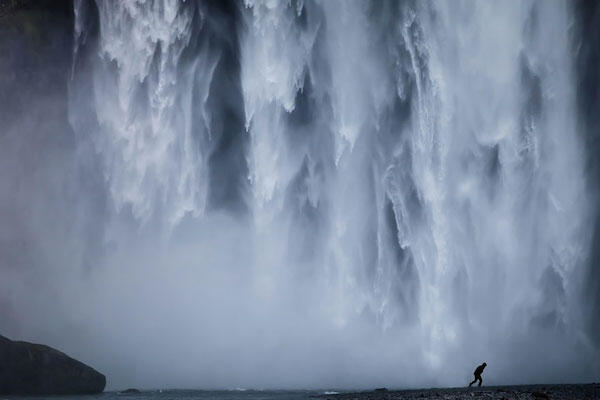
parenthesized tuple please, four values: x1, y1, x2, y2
(0, 336, 106, 395)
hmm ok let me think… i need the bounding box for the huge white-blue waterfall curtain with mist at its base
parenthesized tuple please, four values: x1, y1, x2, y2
(2, 0, 600, 387)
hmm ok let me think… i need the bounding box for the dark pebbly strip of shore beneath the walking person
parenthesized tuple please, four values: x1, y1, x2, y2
(315, 383, 600, 400)
